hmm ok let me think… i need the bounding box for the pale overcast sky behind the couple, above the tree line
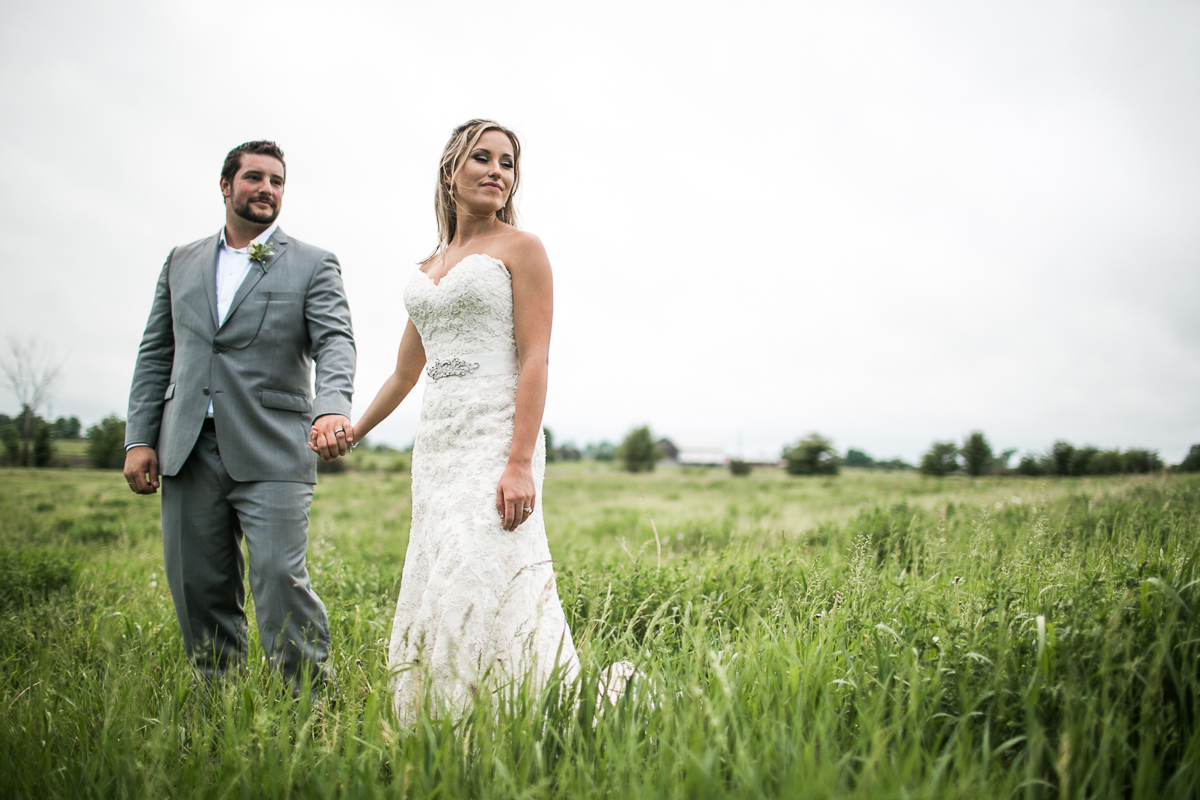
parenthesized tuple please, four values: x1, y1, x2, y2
(0, 0, 1200, 461)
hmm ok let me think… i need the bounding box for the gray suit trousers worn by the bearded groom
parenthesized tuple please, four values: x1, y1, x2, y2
(162, 422, 329, 688)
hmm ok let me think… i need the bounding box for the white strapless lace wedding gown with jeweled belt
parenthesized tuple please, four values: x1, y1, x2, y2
(389, 255, 578, 721)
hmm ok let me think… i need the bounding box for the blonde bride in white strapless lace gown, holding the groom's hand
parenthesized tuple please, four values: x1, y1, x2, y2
(312, 120, 595, 722)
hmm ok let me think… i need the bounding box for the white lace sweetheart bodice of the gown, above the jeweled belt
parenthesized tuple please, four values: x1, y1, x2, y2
(404, 254, 517, 362)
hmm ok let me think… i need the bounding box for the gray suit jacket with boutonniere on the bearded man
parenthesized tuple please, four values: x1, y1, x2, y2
(125, 228, 355, 483)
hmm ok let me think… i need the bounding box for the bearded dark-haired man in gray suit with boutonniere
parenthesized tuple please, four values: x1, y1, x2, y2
(125, 142, 355, 690)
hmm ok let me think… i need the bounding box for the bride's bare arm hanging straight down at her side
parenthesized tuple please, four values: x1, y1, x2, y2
(496, 234, 554, 530)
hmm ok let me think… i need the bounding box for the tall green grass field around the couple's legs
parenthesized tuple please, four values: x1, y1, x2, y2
(0, 465, 1200, 800)
